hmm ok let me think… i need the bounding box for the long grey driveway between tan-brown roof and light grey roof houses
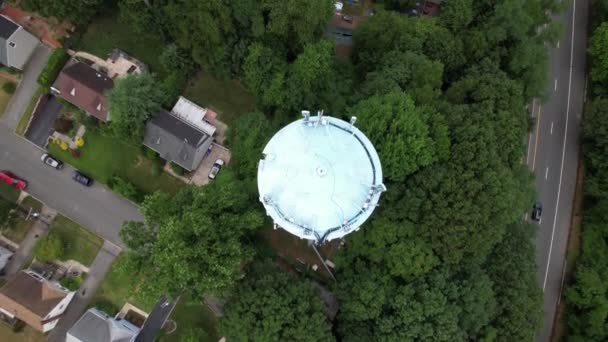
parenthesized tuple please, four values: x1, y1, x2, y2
(47, 241, 120, 342)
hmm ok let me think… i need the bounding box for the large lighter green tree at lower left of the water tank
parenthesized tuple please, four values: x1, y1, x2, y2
(121, 175, 262, 300)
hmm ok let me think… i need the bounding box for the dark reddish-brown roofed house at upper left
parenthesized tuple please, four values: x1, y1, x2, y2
(51, 60, 114, 122)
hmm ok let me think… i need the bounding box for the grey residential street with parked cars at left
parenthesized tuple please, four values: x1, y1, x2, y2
(0, 122, 143, 247)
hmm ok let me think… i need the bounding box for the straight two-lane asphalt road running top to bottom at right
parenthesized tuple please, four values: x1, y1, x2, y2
(527, 0, 589, 341)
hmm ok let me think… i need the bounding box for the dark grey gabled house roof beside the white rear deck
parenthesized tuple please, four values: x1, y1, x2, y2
(144, 110, 213, 170)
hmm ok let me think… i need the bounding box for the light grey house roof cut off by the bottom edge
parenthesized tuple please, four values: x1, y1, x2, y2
(66, 308, 139, 342)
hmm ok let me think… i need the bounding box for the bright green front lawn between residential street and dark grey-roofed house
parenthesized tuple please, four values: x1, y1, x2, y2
(48, 130, 185, 193)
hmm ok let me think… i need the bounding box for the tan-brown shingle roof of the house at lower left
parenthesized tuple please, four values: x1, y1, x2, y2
(0, 271, 68, 330)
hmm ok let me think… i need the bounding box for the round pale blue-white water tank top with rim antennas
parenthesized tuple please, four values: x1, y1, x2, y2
(258, 115, 386, 243)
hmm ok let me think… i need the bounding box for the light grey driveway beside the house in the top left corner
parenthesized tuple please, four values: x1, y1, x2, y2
(2, 44, 51, 131)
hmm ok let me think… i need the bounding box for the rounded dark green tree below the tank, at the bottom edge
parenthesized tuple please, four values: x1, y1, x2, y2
(219, 262, 334, 342)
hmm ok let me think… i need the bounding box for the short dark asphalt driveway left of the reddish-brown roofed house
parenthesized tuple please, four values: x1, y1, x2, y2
(25, 95, 62, 148)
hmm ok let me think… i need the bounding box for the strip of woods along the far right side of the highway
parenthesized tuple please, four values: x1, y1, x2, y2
(565, 0, 608, 341)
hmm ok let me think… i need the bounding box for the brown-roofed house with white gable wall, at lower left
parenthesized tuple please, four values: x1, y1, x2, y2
(0, 270, 76, 333)
